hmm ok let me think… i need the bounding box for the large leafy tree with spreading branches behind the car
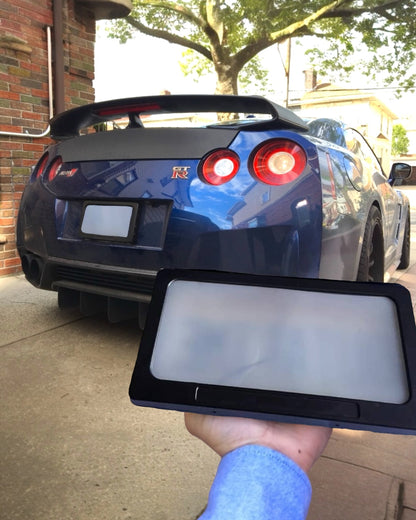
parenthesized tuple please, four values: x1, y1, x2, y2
(110, 0, 416, 94)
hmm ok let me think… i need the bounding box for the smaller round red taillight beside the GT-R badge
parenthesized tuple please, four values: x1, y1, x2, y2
(199, 149, 240, 186)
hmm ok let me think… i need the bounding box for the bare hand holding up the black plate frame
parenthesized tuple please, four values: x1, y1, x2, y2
(185, 413, 332, 472)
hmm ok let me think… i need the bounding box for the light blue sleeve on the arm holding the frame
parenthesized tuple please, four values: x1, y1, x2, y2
(199, 445, 312, 520)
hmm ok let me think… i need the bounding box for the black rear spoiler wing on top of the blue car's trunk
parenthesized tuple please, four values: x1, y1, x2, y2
(50, 95, 308, 140)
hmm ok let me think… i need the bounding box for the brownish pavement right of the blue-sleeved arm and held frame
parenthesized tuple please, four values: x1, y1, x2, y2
(308, 260, 416, 520)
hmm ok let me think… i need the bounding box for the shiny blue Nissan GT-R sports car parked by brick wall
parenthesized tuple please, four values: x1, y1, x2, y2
(17, 95, 410, 321)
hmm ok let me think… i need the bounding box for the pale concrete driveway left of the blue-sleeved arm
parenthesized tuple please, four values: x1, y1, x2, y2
(0, 276, 218, 520)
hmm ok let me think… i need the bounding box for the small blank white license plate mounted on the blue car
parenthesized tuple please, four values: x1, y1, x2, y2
(81, 204, 137, 241)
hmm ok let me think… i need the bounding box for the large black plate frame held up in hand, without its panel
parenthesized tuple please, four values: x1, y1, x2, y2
(129, 269, 416, 434)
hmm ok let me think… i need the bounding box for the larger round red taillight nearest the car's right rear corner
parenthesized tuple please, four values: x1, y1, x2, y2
(249, 139, 306, 186)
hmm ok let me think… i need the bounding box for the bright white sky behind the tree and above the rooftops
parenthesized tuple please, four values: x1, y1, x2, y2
(94, 22, 416, 117)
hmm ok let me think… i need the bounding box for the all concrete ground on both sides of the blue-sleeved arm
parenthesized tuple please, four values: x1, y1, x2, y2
(0, 238, 416, 520)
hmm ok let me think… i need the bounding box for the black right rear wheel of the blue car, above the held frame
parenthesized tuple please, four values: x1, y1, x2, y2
(357, 206, 384, 282)
